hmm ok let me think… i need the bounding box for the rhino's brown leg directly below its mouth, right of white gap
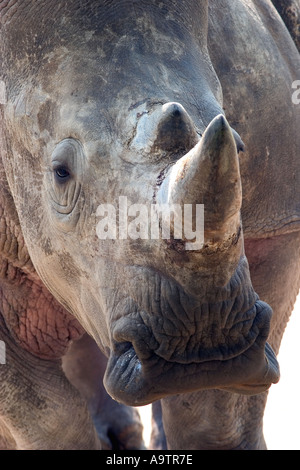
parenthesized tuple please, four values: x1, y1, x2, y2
(162, 390, 267, 450)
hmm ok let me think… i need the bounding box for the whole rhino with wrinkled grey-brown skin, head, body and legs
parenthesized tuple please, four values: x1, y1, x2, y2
(0, 0, 300, 449)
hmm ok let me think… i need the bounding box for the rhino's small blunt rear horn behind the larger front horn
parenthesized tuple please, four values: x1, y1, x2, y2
(152, 102, 199, 153)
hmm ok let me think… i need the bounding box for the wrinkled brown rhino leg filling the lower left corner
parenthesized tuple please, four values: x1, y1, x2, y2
(0, 319, 100, 450)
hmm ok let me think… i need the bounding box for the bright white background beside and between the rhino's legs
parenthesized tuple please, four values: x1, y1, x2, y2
(139, 295, 300, 450)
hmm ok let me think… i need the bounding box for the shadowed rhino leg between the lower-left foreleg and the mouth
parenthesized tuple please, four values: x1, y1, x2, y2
(63, 334, 145, 450)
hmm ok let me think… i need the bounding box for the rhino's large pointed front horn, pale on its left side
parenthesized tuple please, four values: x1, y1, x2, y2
(157, 114, 242, 241)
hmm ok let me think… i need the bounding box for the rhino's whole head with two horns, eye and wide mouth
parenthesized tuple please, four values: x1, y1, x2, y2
(3, 2, 278, 405)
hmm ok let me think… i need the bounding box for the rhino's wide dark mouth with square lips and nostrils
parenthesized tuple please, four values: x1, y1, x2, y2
(104, 301, 279, 406)
